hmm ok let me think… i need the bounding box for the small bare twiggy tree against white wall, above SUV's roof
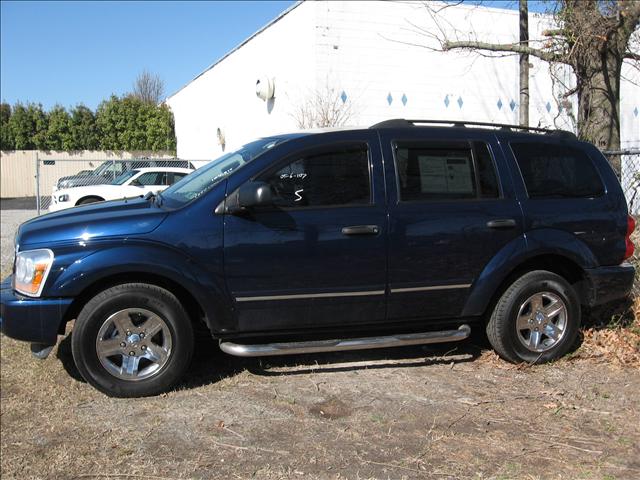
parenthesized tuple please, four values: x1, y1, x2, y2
(292, 85, 354, 129)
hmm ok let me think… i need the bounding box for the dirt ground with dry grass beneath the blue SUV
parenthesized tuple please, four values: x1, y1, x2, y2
(0, 212, 640, 480)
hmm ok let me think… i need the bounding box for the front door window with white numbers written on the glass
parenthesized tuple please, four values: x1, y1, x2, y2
(259, 145, 371, 208)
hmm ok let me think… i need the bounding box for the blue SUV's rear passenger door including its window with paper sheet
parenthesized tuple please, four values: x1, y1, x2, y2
(381, 128, 523, 321)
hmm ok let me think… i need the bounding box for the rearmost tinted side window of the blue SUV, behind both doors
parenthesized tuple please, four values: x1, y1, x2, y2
(511, 143, 604, 198)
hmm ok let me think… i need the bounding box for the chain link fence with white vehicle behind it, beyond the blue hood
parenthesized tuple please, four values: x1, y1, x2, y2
(34, 157, 196, 215)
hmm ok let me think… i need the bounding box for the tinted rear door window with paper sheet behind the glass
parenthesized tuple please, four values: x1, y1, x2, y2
(395, 142, 500, 202)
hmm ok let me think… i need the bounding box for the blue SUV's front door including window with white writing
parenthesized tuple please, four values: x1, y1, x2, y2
(224, 132, 387, 332)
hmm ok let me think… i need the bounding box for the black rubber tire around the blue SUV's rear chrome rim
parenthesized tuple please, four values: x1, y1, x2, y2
(487, 270, 581, 363)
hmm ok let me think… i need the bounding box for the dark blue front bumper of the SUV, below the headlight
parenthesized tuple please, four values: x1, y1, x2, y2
(0, 277, 73, 345)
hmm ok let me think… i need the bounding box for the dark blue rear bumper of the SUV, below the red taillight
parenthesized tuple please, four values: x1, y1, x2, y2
(585, 263, 635, 307)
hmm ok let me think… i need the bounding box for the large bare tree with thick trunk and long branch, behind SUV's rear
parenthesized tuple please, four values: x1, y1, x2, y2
(422, 0, 640, 150)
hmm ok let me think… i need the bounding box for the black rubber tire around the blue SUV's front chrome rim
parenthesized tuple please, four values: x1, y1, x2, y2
(71, 283, 194, 397)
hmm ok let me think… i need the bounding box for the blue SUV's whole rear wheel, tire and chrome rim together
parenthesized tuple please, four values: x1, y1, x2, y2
(487, 270, 580, 363)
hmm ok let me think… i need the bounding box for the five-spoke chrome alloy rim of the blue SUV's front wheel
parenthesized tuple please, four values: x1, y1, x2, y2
(96, 308, 171, 381)
